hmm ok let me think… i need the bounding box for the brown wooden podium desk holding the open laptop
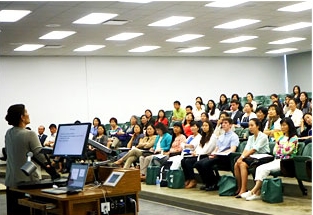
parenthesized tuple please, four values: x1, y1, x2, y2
(10, 167, 141, 215)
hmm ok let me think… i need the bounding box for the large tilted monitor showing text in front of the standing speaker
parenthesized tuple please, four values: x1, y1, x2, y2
(52, 123, 91, 157)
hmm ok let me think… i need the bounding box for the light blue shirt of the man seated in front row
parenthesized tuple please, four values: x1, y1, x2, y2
(216, 131, 239, 152)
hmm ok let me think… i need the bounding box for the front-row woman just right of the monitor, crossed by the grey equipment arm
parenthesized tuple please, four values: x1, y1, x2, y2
(87, 125, 108, 160)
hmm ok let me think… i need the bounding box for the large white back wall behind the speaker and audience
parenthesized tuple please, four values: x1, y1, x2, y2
(0, 57, 284, 152)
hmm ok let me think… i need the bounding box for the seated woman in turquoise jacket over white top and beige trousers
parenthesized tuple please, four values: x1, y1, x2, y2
(139, 123, 172, 180)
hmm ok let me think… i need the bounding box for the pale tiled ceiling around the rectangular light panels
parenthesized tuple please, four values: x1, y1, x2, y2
(0, 1, 312, 57)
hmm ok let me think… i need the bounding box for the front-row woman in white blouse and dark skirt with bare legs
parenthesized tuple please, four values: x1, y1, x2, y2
(234, 118, 270, 198)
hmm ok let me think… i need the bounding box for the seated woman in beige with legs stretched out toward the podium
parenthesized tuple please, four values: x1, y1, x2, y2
(114, 125, 156, 168)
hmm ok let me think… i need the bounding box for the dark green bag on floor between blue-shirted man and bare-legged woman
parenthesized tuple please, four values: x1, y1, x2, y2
(217, 175, 237, 196)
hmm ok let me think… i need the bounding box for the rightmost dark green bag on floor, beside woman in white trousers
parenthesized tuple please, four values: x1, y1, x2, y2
(261, 178, 283, 203)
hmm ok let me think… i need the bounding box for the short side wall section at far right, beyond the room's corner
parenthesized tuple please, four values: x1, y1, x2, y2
(287, 52, 312, 93)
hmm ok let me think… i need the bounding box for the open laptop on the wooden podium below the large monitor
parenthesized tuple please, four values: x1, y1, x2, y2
(41, 163, 88, 195)
